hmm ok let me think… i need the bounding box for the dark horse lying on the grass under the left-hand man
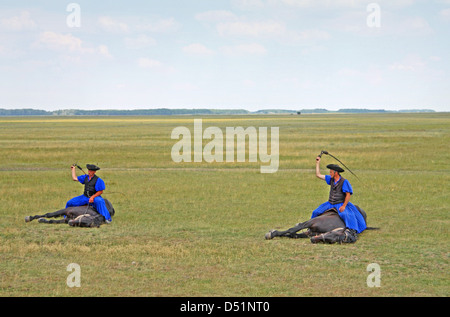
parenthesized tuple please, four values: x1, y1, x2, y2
(25, 199, 115, 228)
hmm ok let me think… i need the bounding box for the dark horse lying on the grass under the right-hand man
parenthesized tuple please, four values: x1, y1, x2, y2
(265, 206, 375, 243)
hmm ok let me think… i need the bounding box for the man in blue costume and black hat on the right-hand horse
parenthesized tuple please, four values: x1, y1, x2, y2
(311, 156, 367, 233)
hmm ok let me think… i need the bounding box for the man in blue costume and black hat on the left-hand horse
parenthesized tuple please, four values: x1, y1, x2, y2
(66, 164, 112, 223)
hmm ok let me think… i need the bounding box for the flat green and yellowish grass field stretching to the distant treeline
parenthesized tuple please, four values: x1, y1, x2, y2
(0, 113, 450, 297)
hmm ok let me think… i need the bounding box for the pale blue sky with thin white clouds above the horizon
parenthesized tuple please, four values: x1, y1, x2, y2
(0, 0, 450, 111)
